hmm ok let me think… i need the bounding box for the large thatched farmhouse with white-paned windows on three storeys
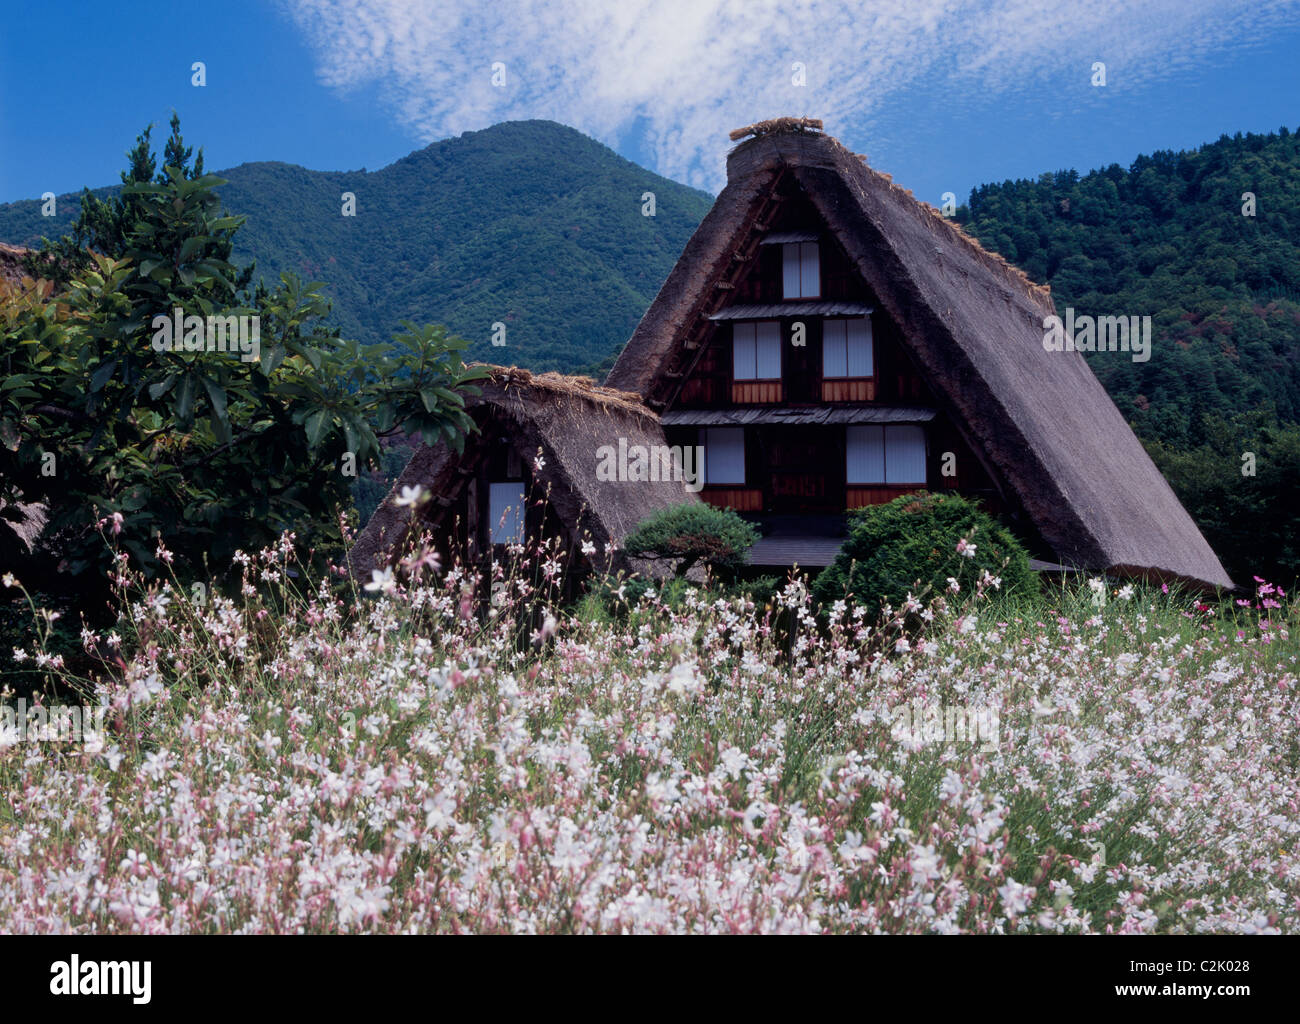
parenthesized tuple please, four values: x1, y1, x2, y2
(605, 120, 1231, 586)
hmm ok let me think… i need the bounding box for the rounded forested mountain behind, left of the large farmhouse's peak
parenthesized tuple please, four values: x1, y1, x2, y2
(0, 121, 712, 372)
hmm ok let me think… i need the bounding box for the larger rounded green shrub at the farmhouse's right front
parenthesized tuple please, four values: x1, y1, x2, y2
(813, 494, 1037, 607)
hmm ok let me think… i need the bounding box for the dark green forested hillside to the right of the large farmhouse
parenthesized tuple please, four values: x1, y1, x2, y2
(957, 129, 1300, 448)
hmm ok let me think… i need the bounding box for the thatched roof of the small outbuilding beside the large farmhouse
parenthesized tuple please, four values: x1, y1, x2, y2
(348, 366, 698, 578)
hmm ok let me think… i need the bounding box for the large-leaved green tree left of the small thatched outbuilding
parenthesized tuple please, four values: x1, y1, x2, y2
(0, 122, 484, 608)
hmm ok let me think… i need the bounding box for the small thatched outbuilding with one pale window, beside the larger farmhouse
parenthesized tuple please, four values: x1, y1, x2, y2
(348, 366, 698, 580)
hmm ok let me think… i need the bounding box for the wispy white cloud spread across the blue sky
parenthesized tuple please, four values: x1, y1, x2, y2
(286, 0, 1300, 187)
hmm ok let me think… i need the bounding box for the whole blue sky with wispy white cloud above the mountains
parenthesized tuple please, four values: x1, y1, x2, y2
(0, 0, 1300, 205)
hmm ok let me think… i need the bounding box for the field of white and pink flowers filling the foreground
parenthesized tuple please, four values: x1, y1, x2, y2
(0, 535, 1300, 933)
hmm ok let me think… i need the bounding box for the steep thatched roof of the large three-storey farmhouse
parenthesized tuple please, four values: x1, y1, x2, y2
(608, 129, 1231, 586)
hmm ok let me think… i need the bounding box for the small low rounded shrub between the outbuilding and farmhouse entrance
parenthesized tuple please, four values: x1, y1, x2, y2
(623, 502, 759, 580)
